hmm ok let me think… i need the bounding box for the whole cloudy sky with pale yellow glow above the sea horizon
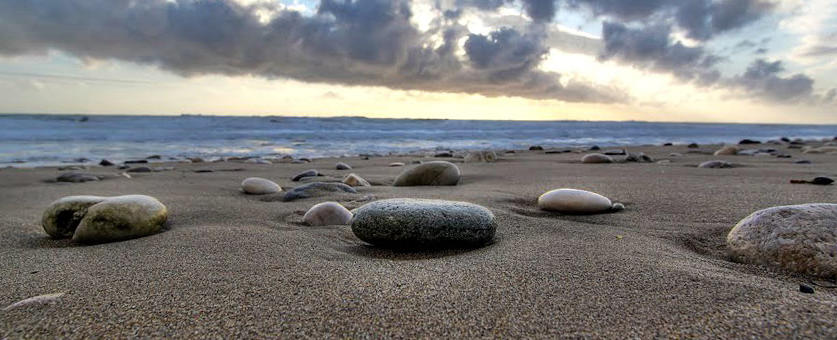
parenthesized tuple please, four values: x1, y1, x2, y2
(0, 0, 837, 123)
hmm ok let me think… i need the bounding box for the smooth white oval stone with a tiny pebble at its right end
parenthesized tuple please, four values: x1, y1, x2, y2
(538, 189, 613, 214)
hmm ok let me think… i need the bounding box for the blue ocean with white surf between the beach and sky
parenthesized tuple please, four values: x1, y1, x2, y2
(0, 114, 837, 167)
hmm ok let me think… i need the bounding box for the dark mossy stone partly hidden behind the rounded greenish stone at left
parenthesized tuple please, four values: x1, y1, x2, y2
(41, 196, 107, 239)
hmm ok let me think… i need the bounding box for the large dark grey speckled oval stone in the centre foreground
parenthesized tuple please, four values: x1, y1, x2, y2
(352, 198, 497, 248)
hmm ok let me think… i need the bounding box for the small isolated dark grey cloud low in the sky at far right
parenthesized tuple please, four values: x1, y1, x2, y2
(731, 59, 814, 102)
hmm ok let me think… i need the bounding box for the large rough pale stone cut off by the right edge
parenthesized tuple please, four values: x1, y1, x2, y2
(727, 203, 837, 278)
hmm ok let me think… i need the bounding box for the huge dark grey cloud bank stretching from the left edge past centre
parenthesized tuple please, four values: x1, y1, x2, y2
(0, 0, 624, 102)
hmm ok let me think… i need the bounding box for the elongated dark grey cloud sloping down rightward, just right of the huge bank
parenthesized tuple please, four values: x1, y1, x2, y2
(599, 22, 720, 84)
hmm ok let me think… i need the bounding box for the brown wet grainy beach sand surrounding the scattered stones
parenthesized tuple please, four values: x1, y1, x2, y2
(0, 146, 837, 339)
